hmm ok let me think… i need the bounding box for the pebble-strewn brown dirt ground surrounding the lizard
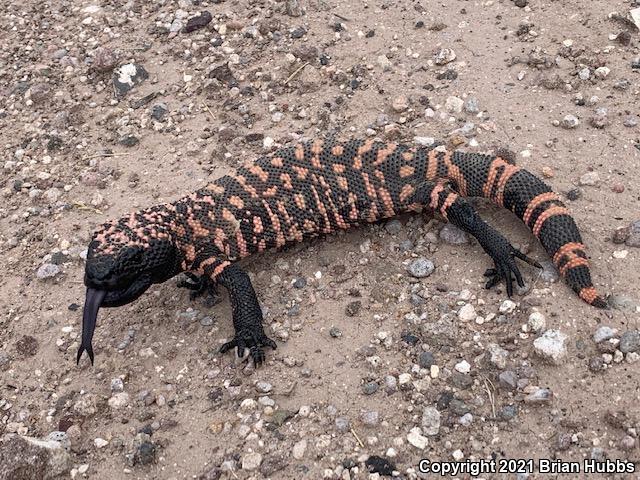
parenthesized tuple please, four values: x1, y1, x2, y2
(0, 0, 640, 479)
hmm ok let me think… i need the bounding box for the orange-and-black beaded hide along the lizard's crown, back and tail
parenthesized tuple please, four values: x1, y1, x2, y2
(90, 140, 606, 308)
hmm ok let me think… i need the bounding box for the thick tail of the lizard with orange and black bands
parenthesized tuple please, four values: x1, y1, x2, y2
(438, 152, 608, 308)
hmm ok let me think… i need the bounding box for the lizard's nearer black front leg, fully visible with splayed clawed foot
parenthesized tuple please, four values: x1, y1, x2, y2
(212, 264, 277, 366)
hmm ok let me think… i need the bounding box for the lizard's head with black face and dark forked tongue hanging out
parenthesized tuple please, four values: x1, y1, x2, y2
(77, 211, 182, 363)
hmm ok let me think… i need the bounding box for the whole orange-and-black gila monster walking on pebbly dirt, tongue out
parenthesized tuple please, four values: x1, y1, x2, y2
(77, 140, 607, 364)
